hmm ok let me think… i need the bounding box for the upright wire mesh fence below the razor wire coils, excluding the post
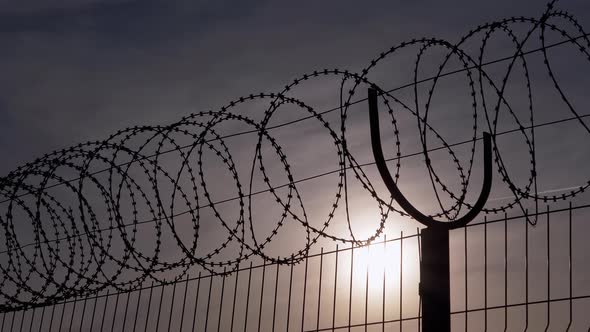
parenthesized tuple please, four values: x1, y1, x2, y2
(0, 205, 590, 332)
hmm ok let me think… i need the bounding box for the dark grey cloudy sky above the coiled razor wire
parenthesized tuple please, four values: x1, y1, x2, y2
(0, 0, 588, 184)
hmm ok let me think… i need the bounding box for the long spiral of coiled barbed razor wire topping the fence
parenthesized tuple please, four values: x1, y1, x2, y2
(0, 1, 590, 311)
